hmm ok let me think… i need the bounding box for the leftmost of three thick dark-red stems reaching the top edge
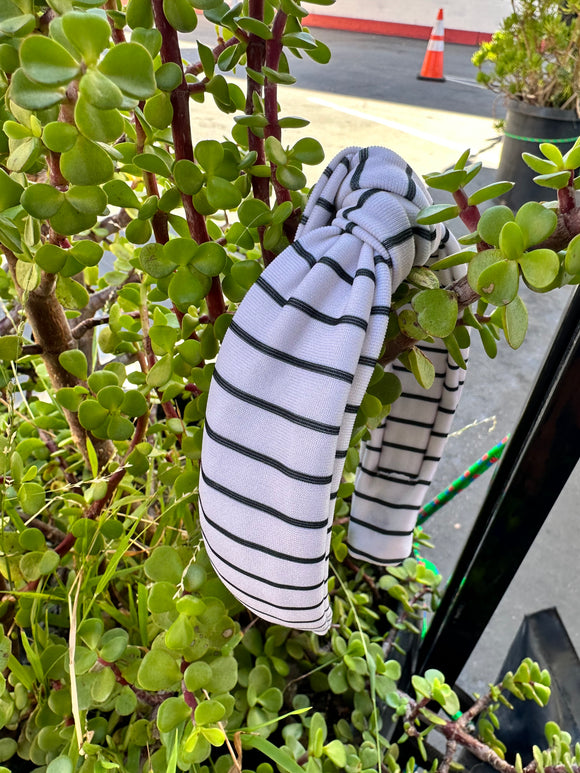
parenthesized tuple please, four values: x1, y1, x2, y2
(152, 0, 226, 322)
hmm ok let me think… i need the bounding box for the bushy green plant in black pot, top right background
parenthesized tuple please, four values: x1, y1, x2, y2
(472, 0, 580, 207)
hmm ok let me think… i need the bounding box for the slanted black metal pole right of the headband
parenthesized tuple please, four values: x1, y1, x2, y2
(417, 288, 580, 684)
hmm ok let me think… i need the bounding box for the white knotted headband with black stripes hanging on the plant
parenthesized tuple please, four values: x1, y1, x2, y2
(199, 147, 462, 634)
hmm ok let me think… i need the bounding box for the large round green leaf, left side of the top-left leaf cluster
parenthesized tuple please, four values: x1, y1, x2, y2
(20, 35, 80, 86)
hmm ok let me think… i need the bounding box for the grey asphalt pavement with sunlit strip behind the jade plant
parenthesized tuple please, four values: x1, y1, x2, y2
(185, 27, 580, 692)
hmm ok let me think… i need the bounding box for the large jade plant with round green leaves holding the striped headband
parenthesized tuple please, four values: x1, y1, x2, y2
(0, 0, 580, 773)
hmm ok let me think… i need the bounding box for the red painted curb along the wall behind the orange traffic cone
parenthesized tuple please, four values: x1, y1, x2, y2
(303, 13, 491, 46)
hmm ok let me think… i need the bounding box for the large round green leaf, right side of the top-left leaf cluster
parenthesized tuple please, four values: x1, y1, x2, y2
(99, 43, 156, 99)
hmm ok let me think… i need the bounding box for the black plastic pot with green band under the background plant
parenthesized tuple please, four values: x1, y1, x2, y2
(497, 100, 580, 209)
